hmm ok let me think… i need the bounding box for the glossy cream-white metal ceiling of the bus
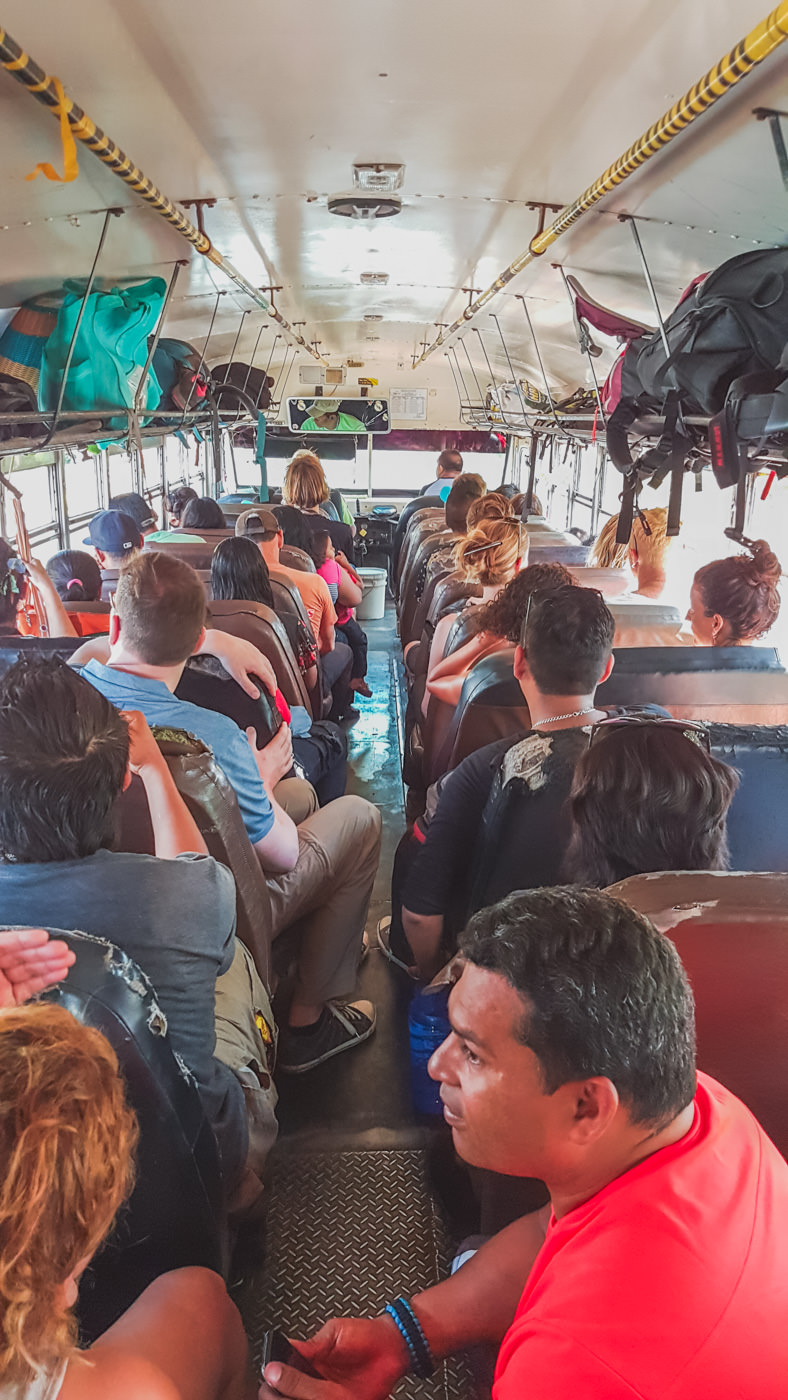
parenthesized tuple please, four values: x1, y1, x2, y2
(0, 0, 788, 473)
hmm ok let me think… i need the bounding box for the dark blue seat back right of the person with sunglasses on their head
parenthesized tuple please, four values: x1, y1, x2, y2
(708, 724, 788, 872)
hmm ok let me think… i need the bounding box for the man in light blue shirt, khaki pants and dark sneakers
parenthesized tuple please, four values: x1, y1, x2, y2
(71, 552, 381, 1074)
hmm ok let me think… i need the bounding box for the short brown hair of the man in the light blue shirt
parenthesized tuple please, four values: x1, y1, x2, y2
(115, 550, 206, 666)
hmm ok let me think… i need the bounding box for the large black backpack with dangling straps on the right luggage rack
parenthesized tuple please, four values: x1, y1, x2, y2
(607, 248, 788, 539)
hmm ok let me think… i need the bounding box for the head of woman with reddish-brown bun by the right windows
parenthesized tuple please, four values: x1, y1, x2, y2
(687, 539, 782, 647)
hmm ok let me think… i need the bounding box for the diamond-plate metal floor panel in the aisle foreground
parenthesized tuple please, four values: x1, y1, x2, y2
(235, 1149, 473, 1400)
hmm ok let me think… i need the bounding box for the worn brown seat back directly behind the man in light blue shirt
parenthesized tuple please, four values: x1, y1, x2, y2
(115, 727, 272, 987)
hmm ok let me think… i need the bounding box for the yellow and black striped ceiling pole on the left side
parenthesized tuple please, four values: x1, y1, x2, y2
(0, 28, 326, 364)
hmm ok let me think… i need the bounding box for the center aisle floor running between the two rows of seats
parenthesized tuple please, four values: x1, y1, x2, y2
(234, 606, 473, 1400)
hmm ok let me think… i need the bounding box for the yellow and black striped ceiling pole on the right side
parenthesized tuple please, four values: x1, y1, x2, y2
(413, 0, 788, 368)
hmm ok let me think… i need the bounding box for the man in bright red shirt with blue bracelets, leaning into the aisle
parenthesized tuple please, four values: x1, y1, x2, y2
(260, 888, 788, 1400)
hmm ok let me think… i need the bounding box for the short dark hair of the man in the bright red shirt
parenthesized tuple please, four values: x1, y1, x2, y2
(460, 890, 696, 1128)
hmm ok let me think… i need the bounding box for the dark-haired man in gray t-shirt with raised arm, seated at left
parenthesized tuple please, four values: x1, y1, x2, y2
(0, 661, 248, 1190)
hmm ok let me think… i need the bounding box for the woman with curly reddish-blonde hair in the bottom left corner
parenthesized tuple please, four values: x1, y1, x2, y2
(0, 1004, 255, 1400)
